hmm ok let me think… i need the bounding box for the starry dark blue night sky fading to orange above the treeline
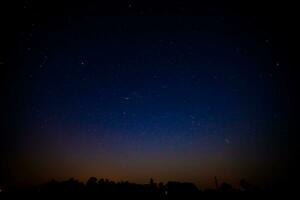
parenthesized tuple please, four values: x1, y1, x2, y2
(0, 1, 296, 187)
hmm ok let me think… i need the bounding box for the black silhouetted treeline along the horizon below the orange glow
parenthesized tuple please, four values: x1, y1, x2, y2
(1, 177, 288, 197)
